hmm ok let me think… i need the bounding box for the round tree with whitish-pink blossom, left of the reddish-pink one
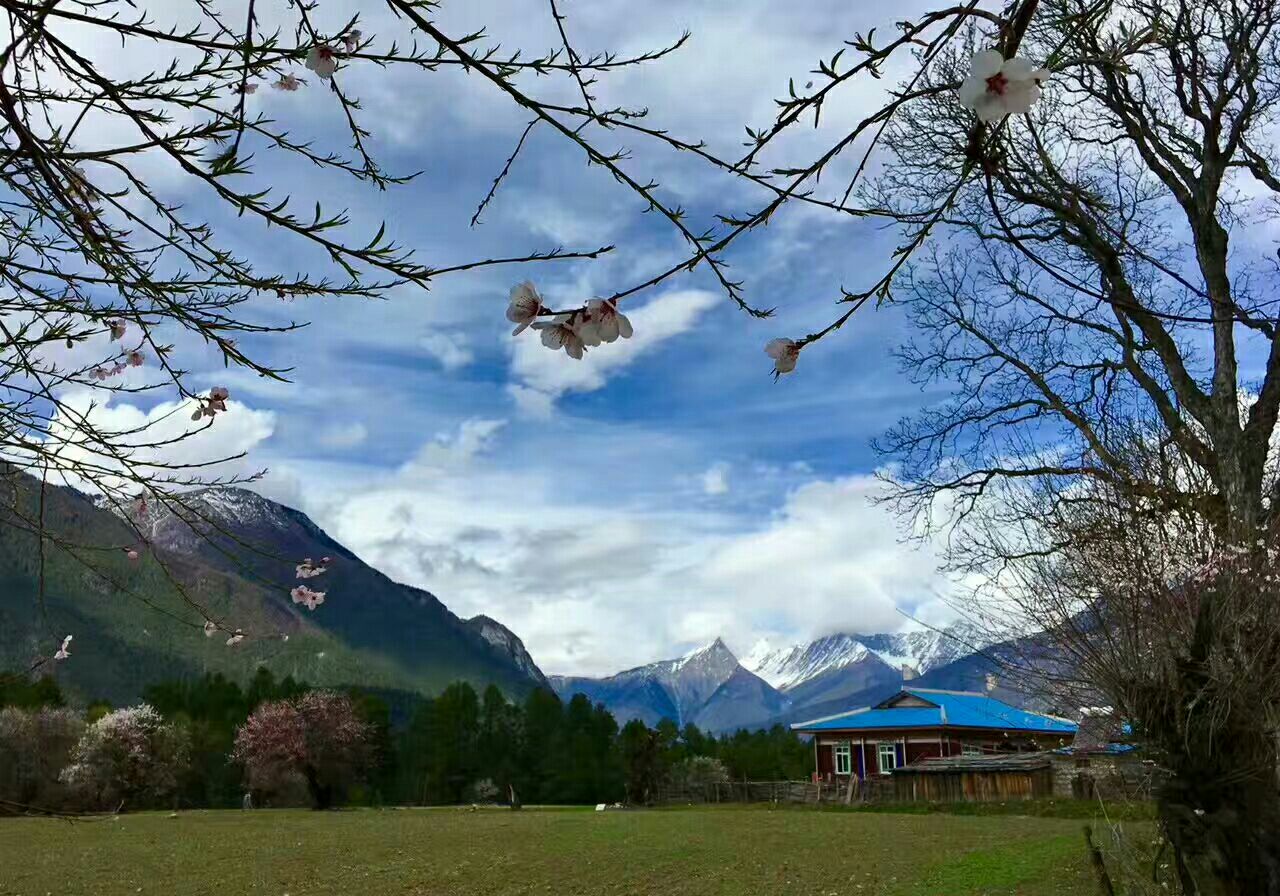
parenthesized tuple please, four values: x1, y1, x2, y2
(60, 703, 187, 809)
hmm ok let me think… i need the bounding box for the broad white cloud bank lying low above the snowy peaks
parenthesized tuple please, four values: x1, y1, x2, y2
(299, 419, 951, 675)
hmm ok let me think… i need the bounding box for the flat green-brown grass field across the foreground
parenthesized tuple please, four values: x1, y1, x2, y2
(0, 808, 1141, 896)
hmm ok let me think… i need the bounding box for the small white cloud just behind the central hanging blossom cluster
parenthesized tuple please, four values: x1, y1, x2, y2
(511, 289, 719, 407)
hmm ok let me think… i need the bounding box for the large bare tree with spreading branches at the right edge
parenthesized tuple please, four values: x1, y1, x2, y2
(868, 0, 1280, 893)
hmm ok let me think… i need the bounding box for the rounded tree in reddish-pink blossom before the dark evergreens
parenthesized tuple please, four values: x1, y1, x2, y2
(232, 691, 370, 809)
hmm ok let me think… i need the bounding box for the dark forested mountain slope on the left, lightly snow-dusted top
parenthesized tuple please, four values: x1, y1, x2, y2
(0, 474, 545, 704)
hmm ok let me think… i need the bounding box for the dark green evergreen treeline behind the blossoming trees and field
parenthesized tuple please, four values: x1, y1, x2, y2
(0, 669, 813, 808)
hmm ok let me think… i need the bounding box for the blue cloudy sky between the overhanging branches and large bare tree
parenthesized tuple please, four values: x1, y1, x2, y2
(42, 0, 977, 675)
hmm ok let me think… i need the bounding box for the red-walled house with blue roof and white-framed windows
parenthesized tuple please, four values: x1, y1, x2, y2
(791, 687, 1076, 781)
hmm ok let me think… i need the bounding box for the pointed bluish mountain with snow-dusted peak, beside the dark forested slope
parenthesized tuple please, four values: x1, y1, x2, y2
(549, 637, 790, 731)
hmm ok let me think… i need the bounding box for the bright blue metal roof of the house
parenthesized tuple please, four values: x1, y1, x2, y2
(791, 687, 1076, 735)
